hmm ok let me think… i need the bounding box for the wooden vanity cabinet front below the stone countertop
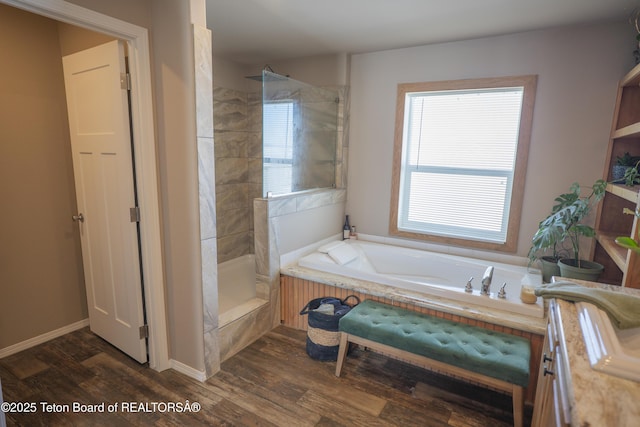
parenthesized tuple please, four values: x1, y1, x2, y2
(531, 300, 571, 427)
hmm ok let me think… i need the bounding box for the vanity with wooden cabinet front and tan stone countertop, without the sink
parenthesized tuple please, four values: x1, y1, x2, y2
(532, 280, 640, 427)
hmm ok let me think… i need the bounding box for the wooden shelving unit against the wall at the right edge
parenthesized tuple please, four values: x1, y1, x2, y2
(592, 65, 640, 288)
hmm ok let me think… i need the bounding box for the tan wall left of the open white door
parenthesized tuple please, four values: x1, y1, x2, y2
(0, 5, 87, 348)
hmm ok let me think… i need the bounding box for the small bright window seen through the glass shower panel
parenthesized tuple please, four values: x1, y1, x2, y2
(262, 101, 293, 196)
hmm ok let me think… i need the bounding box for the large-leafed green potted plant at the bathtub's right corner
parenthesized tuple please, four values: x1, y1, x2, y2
(529, 179, 607, 281)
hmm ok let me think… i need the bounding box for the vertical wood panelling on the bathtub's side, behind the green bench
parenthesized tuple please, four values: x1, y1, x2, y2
(280, 275, 544, 404)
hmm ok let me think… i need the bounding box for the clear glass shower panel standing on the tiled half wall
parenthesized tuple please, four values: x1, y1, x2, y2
(262, 70, 339, 197)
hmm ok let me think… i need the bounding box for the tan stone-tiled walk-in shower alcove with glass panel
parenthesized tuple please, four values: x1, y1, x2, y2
(213, 71, 346, 360)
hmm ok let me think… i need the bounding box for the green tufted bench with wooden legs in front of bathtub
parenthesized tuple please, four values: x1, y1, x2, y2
(336, 300, 531, 427)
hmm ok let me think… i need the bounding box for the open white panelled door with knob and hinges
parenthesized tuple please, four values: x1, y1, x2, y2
(63, 40, 147, 363)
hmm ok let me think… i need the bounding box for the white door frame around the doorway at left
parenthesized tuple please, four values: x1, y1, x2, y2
(0, 0, 171, 371)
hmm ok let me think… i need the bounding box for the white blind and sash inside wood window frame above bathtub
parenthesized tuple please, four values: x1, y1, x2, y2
(398, 87, 524, 243)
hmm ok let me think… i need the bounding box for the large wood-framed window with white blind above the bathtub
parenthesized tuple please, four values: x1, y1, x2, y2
(391, 76, 535, 251)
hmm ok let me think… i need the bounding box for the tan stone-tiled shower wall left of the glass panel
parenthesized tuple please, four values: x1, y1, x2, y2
(213, 87, 262, 263)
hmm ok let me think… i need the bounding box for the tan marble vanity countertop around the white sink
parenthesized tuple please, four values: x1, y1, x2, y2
(557, 279, 640, 427)
